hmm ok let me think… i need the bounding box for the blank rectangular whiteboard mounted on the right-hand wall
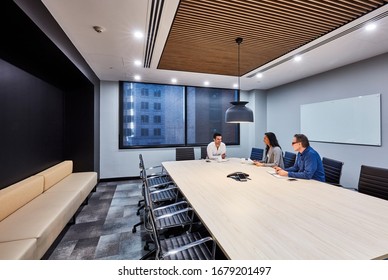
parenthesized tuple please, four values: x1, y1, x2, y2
(300, 94, 381, 146)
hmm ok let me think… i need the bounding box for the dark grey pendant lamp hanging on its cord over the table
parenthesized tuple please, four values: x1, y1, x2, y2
(225, 37, 253, 123)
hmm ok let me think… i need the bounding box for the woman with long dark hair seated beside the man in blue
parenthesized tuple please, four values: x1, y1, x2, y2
(254, 132, 284, 168)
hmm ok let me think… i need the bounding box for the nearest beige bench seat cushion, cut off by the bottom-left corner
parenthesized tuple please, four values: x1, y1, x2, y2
(0, 238, 37, 260)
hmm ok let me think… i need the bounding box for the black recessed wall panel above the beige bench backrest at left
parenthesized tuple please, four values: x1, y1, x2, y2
(0, 59, 64, 188)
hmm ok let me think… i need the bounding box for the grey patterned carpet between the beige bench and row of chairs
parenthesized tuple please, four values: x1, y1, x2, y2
(43, 180, 147, 260)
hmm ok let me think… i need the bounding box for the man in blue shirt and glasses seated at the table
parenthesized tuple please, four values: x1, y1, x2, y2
(275, 134, 325, 182)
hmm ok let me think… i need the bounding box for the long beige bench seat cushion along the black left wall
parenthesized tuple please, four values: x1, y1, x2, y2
(0, 172, 97, 258)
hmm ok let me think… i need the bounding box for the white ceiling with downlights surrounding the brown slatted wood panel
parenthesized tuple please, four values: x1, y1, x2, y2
(42, 0, 388, 90)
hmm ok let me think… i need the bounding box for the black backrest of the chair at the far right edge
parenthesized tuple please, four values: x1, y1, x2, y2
(358, 165, 388, 200)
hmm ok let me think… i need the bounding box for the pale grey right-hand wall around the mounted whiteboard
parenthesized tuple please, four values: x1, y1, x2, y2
(267, 54, 388, 188)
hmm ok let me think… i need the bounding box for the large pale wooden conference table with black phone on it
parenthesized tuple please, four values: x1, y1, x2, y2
(162, 158, 388, 260)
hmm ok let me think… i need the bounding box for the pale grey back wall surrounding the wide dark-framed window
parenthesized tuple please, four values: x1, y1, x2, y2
(100, 81, 266, 179)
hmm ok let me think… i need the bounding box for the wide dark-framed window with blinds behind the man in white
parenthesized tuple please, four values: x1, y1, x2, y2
(119, 82, 239, 149)
